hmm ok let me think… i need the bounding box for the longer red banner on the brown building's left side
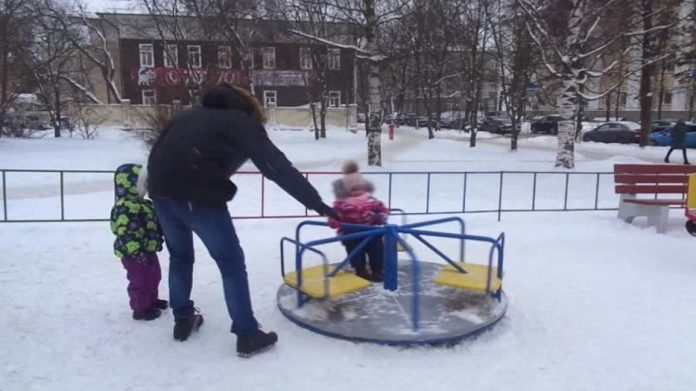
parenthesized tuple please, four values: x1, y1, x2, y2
(131, 68, 248, 88)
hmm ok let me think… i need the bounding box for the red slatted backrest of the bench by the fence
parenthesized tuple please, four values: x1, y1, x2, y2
(614, 164, 696, 194)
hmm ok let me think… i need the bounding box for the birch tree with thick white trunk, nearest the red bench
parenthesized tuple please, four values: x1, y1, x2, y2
(515, 0, 666, 168)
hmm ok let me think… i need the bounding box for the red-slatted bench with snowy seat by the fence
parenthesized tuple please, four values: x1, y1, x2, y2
(614, 164, 696, 233)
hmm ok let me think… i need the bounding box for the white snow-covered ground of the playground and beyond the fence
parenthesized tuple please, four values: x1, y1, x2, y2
(0, 128, 696, 391)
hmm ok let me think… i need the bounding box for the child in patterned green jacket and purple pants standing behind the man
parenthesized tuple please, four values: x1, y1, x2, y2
(111, 164, 168, 320)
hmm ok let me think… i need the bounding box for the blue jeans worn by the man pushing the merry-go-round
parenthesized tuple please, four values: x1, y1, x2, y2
(153, 198, 259, 335)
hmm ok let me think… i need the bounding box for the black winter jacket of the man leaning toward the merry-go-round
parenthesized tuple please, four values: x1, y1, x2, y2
(148, 102, 322, 210)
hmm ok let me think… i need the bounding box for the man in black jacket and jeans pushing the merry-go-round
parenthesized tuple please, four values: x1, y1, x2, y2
(148, 85, 335, 356)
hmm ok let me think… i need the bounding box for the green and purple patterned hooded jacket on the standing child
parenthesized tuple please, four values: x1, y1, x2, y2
(111, 164, 162, 261)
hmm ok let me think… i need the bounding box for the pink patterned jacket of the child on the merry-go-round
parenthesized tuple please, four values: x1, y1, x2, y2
(329, 192, 389, 233)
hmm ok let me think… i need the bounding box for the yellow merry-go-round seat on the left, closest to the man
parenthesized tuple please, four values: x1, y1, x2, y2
(284, 265, 372, 299)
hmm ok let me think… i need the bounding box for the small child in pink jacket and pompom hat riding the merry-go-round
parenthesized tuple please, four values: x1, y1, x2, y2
(329, 161, 389, 282)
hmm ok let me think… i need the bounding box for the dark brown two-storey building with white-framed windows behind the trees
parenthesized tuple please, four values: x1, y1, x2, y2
(85, 13, 356, 106)
